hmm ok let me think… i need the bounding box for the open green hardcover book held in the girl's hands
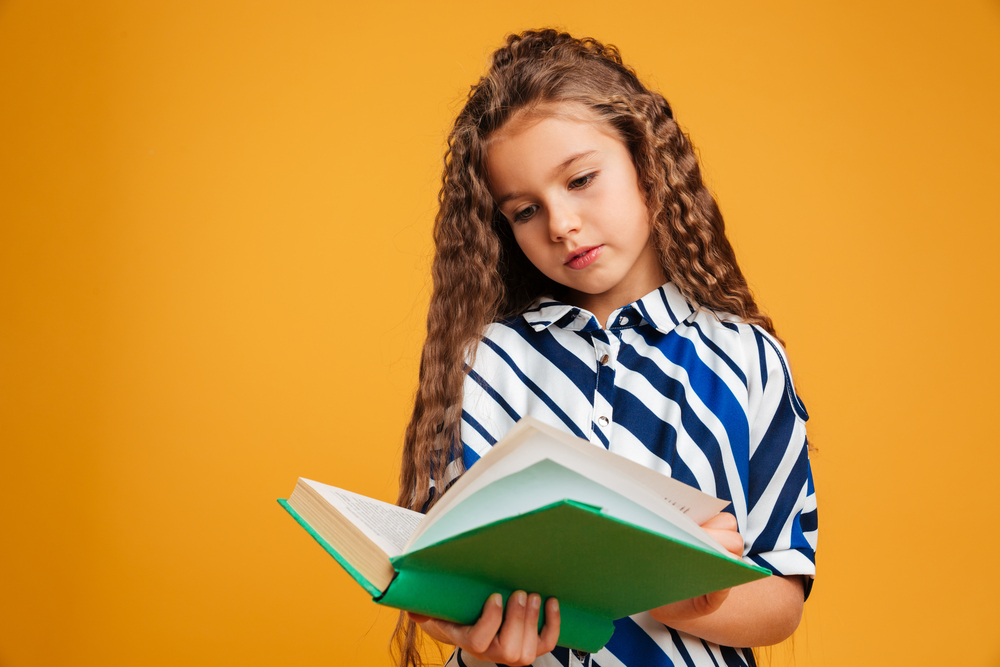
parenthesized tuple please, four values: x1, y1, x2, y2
(278, 417, 770, 652)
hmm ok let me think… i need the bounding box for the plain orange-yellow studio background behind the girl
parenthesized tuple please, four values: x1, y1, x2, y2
(0, 0, 1000, 667)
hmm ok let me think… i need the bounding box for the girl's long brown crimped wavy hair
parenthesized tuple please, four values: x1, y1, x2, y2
(394, 30, 775, 667)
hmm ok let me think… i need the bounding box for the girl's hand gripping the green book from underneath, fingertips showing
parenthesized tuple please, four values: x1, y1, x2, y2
(407, 591, 559, 667)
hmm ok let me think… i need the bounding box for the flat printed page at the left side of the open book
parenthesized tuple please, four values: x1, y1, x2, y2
(302, 479, 424, 558)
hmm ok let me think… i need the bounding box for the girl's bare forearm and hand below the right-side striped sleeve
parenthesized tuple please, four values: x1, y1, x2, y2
(649, 513, 804, 646)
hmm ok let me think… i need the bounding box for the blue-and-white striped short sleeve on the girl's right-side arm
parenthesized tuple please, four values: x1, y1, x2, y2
(743, 327, 817, 595)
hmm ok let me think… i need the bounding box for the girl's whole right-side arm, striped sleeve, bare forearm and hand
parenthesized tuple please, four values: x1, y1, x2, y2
(651, 325, 816, 646)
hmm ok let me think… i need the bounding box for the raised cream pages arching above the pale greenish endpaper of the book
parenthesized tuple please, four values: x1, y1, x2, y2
(404, 417, 729, 555)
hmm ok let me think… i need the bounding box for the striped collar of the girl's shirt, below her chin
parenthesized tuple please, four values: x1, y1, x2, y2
(522, 283, 696, 333)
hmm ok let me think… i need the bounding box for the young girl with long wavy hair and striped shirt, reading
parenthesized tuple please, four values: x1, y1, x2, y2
(397, 30, 816, 667)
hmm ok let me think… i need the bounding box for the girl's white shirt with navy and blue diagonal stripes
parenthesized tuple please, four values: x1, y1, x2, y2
(448, 283, 817, 667)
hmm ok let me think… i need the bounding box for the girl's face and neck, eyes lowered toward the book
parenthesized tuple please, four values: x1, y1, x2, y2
(486, 103, 666, 323)
